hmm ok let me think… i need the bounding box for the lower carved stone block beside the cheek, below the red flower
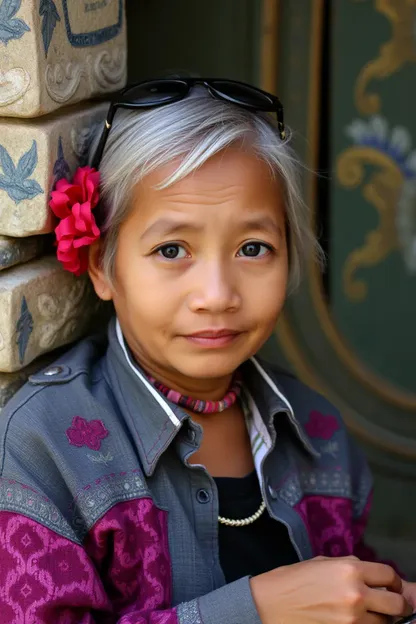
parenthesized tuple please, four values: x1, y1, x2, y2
(0, 256, 100, 372)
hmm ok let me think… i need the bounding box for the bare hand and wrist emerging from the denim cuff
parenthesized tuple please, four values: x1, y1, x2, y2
(250, 557, 412, 624)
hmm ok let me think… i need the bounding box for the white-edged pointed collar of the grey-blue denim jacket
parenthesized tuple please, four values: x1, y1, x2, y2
(106, 318, 319, 476)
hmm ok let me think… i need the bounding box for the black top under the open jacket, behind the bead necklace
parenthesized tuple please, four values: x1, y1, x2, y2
(215, 472, 299, 583)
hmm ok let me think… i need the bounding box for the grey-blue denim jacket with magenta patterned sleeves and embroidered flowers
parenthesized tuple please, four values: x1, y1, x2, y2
(0, 319, 371, 624)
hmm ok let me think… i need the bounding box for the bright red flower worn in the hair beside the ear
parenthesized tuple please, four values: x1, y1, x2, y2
(49, 167, 100, 276)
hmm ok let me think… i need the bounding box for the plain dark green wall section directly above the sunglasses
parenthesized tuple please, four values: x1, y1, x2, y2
(127, 0, 260, 81)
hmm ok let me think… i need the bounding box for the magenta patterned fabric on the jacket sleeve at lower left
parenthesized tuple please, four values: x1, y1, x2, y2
(0, 499, 177, 624)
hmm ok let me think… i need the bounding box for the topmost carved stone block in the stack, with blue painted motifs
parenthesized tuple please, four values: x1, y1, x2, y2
(0, 0, 127, 117)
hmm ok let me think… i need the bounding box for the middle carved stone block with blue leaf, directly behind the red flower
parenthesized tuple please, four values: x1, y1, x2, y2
(0, 101, 108, 237)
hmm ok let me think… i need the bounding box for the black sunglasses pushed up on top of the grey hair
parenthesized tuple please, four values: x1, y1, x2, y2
(91, 78, 286, 169)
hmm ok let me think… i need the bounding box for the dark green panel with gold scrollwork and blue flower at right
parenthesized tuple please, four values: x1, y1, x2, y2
(330, 0, 416, 393)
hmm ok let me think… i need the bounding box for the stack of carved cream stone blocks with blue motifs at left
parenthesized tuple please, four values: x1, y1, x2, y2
(0, 0, 127, 410)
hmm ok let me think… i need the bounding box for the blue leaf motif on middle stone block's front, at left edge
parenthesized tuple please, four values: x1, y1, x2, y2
(0, 141, 43, 204)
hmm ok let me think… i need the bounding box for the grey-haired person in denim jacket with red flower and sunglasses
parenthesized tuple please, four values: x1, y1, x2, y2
(0, 80, 415, 624)
